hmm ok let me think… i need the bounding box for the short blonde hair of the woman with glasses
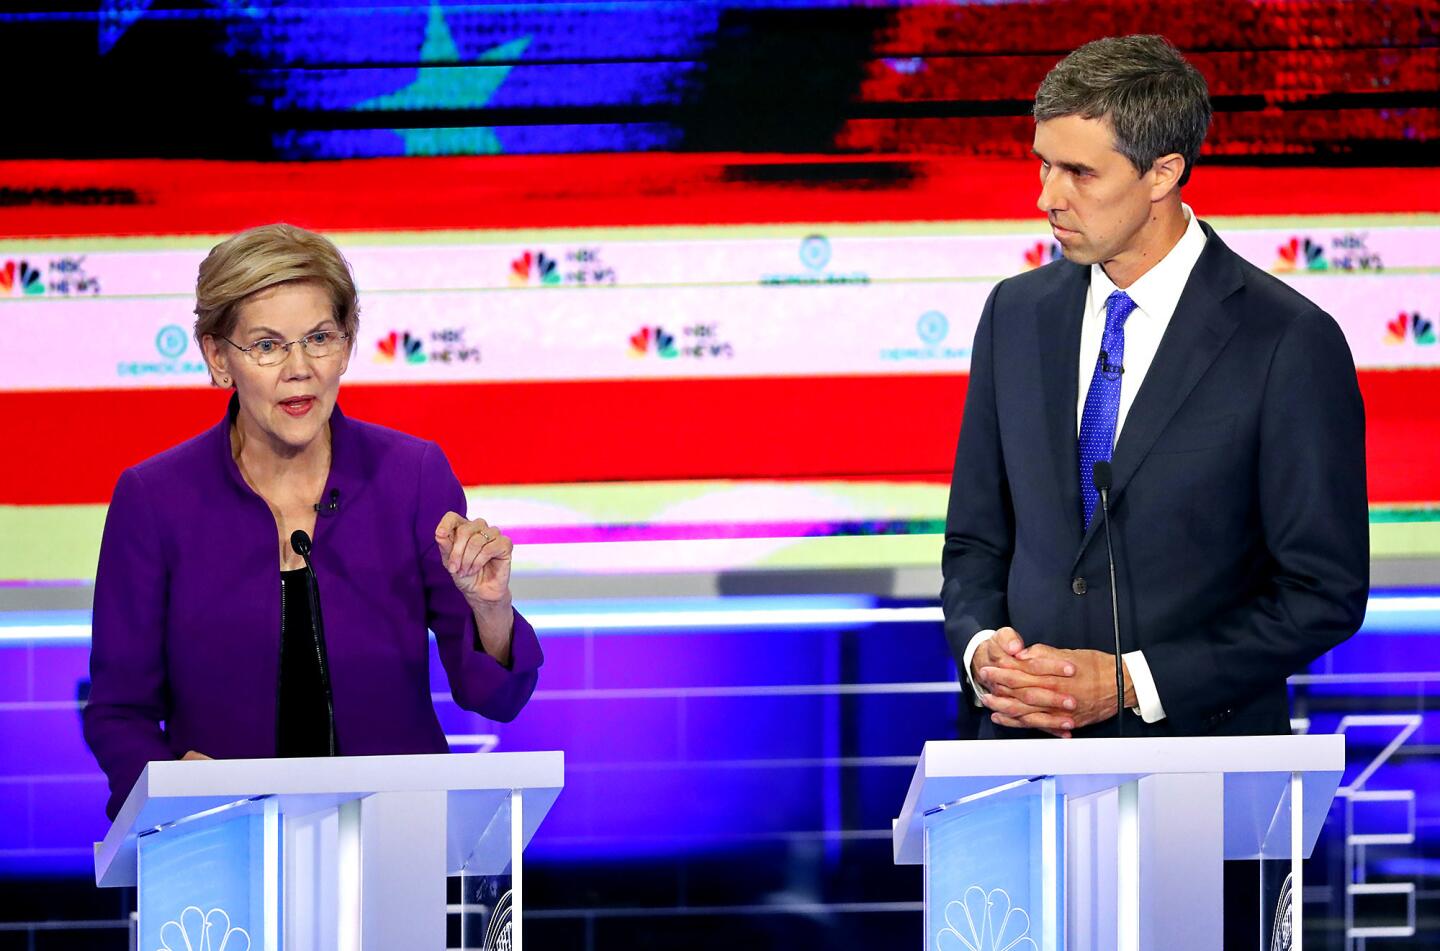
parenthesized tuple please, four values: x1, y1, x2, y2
(194, 223, 360, 377)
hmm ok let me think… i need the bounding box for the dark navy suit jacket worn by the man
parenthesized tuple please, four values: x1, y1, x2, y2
(942, 220, 1369, 736)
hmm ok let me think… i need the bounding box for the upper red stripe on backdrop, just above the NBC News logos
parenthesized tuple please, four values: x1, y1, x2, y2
(0, 153, 1440, 238)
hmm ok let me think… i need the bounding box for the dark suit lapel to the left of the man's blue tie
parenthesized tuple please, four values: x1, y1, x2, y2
(1035, 262, 1090, 540)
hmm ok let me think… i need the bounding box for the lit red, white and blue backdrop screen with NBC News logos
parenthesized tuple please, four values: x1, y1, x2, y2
(0, 0, 1440, 947)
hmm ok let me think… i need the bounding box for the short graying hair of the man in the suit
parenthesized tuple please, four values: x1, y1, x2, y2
(1035, 36, 1210, 184)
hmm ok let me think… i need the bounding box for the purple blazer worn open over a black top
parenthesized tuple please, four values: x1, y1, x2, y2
(84, 399, 543, 818)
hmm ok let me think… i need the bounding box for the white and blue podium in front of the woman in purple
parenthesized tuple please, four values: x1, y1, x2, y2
(95, 752, 564, 951)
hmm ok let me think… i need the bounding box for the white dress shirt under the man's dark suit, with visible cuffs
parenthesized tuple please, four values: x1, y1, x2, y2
(965, 205, 1205, 723)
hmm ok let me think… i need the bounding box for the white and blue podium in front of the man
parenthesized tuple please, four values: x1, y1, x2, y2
(893, 735, 1345, 951)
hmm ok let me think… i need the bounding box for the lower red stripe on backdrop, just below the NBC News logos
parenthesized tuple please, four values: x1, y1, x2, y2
(0, 370, 1440, 504)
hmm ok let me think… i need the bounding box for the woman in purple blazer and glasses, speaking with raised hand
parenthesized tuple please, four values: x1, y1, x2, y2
(84, 225, 543, 818)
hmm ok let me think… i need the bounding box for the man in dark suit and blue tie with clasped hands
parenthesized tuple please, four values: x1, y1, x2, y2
(942, 36, 1369, 736)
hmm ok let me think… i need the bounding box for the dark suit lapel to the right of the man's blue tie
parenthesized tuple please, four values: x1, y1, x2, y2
(1071, 222, 1244, 563)
